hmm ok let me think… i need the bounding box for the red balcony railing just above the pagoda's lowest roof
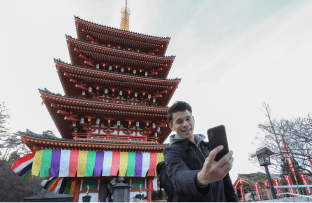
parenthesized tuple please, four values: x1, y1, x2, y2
(72, 133, 159, 142)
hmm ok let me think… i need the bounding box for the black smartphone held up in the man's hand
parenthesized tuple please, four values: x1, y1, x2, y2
(207, 125, 229, 161)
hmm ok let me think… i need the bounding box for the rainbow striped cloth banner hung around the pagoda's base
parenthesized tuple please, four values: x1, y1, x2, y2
(12, 149, 164, 178)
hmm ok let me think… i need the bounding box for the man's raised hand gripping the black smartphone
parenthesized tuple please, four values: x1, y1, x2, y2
(197, 145, 234, 185)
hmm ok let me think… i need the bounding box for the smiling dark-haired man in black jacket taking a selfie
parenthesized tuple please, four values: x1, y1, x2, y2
(164, 101, 238, 202)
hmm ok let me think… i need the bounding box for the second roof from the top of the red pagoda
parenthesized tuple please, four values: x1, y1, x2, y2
(66, 36, 175, 78)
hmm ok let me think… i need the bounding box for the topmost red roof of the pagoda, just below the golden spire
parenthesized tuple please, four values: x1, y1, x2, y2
(75, 16, 170, 56)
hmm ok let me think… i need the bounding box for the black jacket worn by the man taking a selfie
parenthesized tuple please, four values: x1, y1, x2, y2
(164, 135, 238, 202)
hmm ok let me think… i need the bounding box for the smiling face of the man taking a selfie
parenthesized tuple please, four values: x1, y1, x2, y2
(169, 110, 195, 139)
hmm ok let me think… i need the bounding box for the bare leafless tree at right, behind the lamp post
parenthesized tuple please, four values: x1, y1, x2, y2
(249, 103, 312, 176)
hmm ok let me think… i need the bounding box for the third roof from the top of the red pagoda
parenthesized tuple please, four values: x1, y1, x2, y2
(54, 59, 181, 105)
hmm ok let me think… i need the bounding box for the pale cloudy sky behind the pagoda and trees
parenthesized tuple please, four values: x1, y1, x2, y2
(0, 0, 312, 181)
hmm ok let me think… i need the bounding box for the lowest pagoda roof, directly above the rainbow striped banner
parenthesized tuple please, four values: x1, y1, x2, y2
(18, 129, 169, 153)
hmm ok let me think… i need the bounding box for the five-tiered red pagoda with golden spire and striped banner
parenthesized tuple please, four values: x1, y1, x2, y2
(12, 1, 180, 202)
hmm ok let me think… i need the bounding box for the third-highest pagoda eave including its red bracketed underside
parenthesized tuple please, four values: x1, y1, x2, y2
(55, 60, 181, 106)
